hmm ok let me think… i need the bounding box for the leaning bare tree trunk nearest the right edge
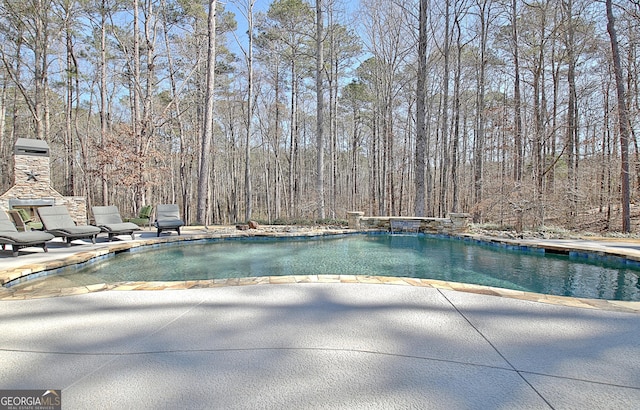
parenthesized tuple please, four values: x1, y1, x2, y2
(606, 0, 631, 233)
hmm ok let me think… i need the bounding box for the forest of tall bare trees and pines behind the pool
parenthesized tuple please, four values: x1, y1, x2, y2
(0, 0, 640, 232)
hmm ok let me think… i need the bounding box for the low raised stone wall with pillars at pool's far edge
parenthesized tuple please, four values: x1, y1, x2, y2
(347, 211, 471, 235)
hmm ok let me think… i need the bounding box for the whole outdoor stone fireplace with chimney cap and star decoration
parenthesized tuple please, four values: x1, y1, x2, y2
(0, 138, 87, 224)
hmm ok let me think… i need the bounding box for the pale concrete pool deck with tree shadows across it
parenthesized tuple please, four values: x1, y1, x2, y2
(0, 227, 640, 409)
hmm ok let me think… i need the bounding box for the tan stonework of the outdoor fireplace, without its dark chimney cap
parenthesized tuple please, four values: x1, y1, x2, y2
(0, 154, 87, 225)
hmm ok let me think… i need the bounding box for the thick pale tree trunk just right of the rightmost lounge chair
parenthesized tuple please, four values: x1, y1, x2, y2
(196, 0, 217, 225)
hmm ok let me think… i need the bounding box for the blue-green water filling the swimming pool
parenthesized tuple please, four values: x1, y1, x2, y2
(11, 234, 640, 301)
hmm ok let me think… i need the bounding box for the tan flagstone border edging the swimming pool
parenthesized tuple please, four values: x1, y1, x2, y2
(0, 229, 640, 313)
